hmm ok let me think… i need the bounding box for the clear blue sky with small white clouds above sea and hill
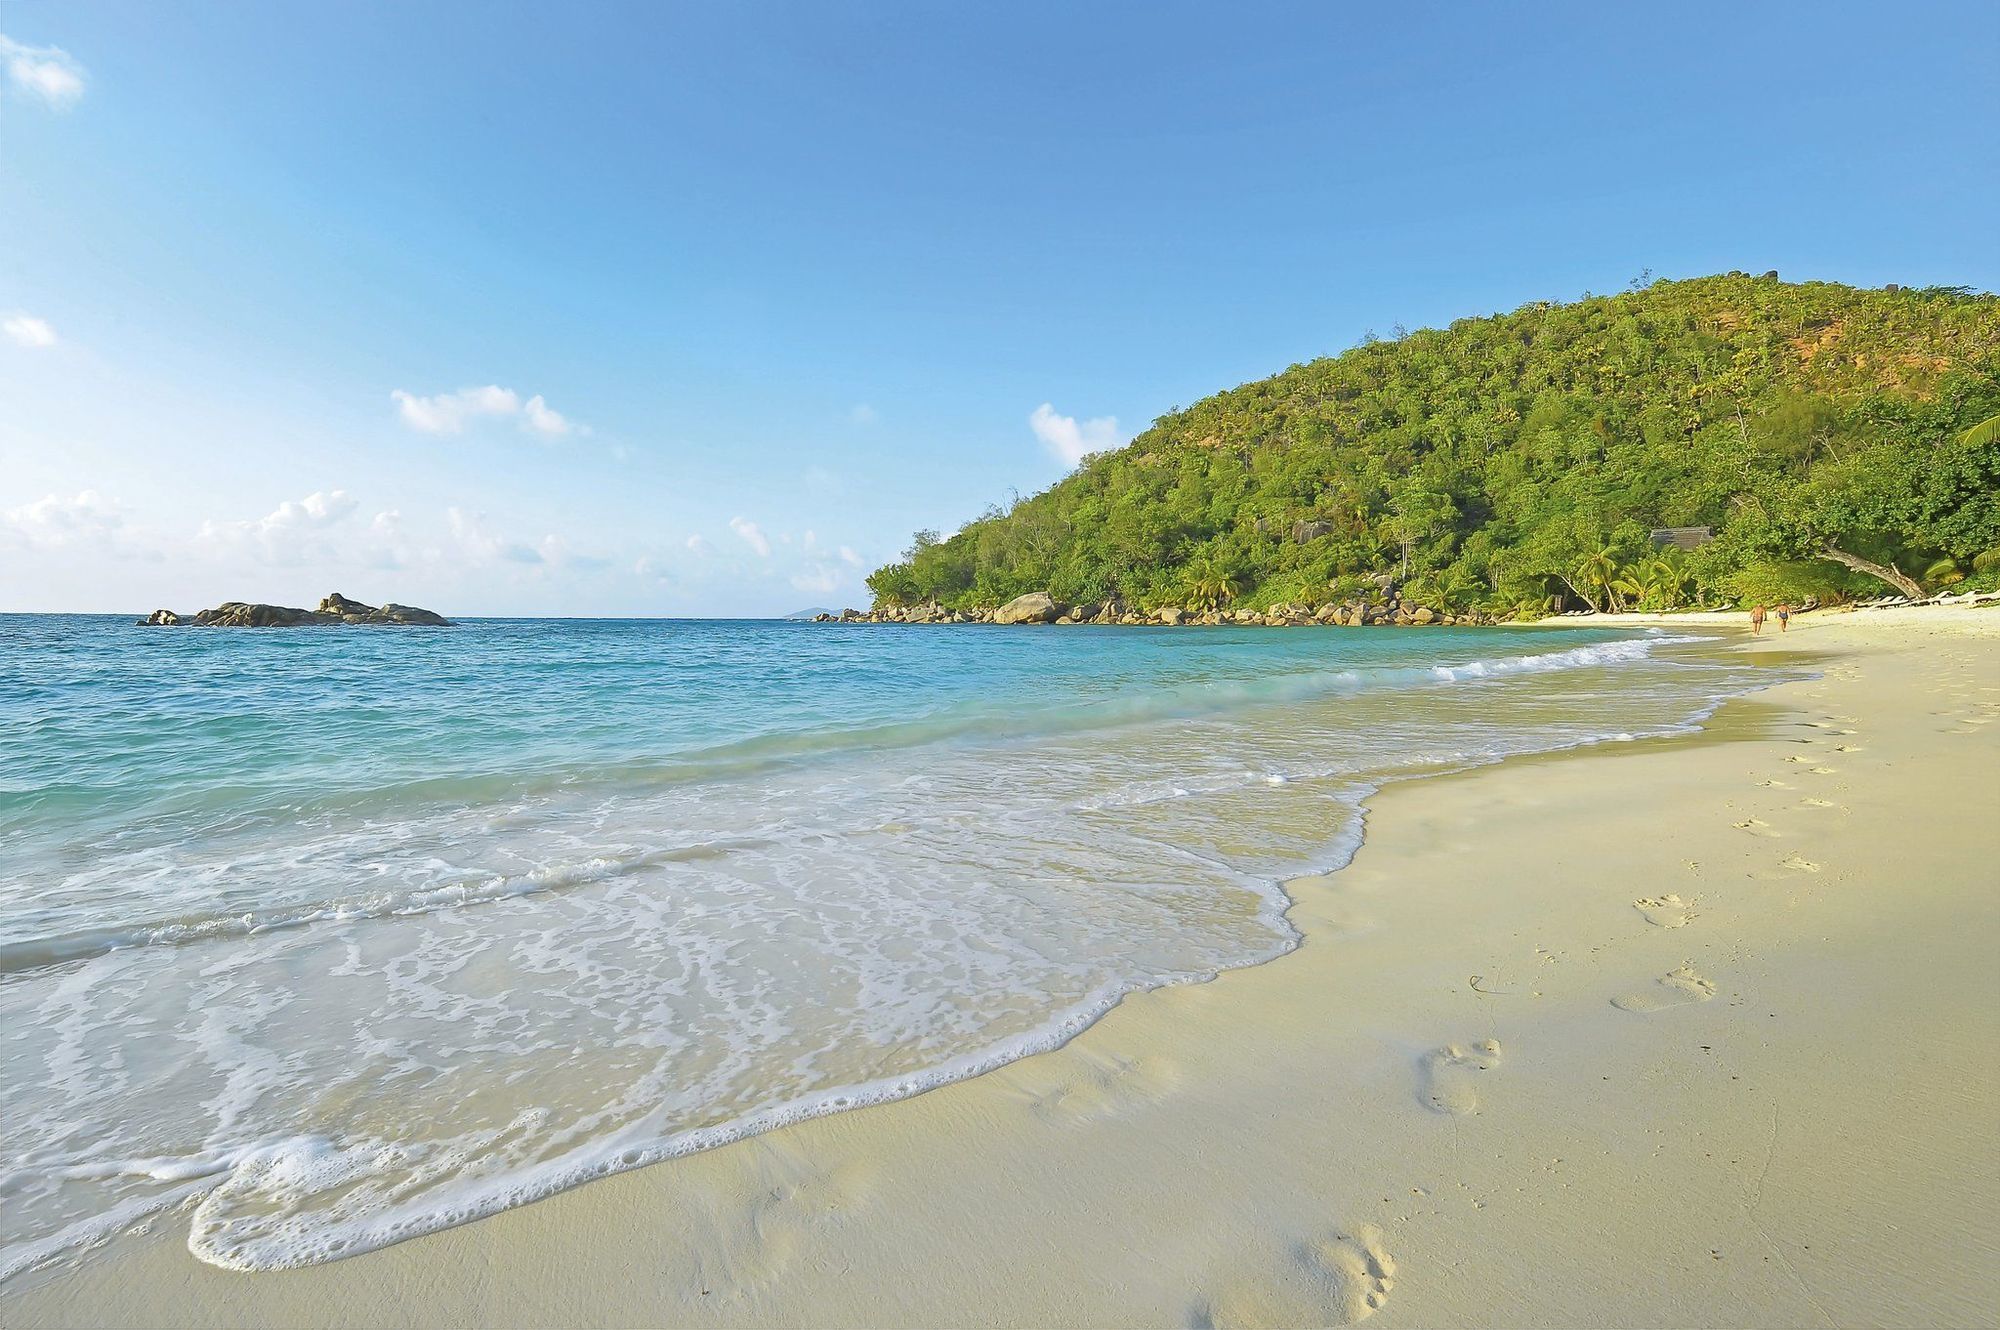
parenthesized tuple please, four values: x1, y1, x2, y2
(0, 0, 2000, 614)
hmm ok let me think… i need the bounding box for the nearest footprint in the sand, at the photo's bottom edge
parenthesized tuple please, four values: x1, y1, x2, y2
(1188, 1224, 1396, 1330)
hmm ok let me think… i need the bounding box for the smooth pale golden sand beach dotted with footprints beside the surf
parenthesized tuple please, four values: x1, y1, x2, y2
(0, 610, 2000, 1324)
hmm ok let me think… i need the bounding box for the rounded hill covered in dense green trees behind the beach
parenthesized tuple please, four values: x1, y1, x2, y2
(868, 274, 2000, 612)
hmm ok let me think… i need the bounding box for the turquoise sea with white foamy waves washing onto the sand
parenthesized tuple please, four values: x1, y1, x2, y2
(0, 616, 1770, 1280)
